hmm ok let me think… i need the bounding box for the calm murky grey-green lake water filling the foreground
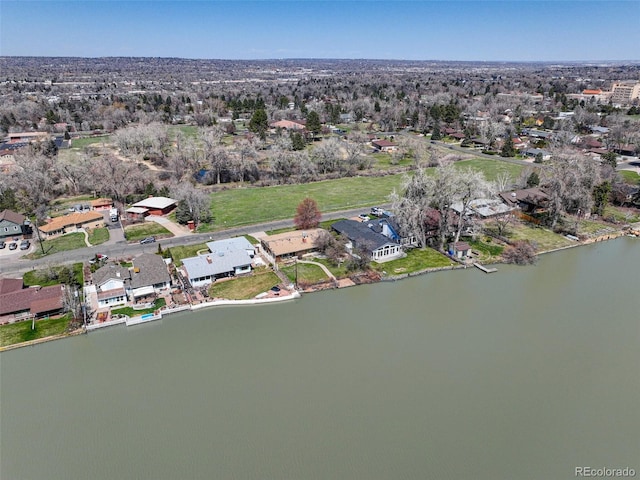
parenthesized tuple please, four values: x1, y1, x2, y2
(0, 238, 640, 480)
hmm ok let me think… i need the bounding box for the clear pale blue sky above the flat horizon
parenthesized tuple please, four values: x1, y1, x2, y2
(0, 0, 640, 61)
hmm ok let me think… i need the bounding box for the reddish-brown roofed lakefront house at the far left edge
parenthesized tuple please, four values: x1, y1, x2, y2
(0, 279, 65, 324)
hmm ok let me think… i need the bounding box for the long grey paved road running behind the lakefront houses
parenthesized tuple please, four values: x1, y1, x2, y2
(0, 204, 390, 276)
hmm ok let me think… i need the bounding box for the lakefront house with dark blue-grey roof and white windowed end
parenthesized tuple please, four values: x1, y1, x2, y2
(331, 220, 402, 262)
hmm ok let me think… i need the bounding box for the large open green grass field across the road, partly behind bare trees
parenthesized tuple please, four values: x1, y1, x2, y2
(211, 159, 522, 230)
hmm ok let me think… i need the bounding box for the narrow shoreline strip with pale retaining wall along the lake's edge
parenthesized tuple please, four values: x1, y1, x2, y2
(0, 231, 628, 353)
